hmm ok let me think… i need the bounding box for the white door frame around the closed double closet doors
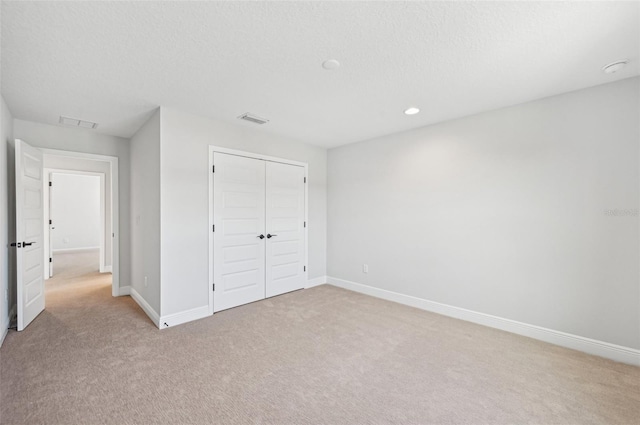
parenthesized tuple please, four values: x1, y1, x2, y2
(209, 145, 309, 315)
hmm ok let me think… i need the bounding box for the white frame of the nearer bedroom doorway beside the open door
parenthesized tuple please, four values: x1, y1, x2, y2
(39, 148, 121, 297)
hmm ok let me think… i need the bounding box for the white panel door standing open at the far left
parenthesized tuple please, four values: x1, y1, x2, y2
(15, 140, 44, 331)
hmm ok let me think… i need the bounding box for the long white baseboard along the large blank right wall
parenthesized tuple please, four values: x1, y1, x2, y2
(327, 276, 640, 366)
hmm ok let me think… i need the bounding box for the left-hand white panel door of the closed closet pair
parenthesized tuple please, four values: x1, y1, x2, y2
(213, 152, 266, 311)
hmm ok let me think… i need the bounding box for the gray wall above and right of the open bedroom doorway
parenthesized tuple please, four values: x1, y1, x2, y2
(13, 119, 131, 287)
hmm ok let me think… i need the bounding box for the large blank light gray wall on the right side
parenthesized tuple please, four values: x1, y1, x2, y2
(328, 78, 640, 348)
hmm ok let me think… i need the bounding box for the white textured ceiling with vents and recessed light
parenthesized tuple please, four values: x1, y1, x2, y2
(2, 1, 640, 147)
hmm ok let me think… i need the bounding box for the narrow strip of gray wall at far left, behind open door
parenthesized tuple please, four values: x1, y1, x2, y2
(0, 96, 16, 336)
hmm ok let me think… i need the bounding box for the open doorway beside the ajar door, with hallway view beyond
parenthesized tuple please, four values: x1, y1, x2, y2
(42, 149, 122, 296)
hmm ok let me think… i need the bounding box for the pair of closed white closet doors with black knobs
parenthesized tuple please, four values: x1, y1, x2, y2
(213, 152, 306, 312)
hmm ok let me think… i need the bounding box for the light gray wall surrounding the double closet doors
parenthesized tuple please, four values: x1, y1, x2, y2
(161, 108, 327, 316)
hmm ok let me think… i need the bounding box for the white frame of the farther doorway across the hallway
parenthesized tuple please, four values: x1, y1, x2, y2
(44, 168, 106, 279)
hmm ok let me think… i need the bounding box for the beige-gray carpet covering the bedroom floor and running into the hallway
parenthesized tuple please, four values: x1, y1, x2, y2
(0, 253, 640, 424)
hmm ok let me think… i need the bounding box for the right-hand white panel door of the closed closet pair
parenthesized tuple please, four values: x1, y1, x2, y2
(266, 162, 306, 297)
